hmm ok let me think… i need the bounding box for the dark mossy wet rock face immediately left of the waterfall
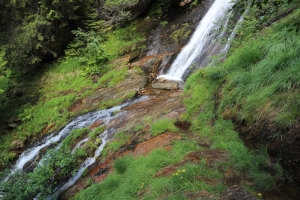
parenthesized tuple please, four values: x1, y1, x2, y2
(146, 0, 214, 72)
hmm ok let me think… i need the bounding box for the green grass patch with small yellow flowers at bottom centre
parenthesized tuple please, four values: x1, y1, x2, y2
(74, 140, 206, 200)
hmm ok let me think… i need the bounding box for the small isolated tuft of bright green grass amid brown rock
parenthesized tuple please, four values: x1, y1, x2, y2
(150, 118, 178, 136)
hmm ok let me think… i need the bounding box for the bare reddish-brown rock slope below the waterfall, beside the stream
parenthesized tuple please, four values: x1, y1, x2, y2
(60, 88, 185, 199)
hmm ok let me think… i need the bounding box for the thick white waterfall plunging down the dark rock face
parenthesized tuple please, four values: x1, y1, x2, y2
(158, 0, 233, 81)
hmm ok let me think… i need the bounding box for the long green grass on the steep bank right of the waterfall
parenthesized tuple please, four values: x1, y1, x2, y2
(183, 9, 300, 191)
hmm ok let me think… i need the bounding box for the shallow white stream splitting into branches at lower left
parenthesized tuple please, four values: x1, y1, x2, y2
(0, 96, 148, 199)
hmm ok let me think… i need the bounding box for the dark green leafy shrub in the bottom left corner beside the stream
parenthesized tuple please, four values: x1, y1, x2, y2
(0, 149, 78, 200)
